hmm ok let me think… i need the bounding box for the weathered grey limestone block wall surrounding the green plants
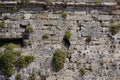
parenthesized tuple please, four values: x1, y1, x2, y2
(0, 0, 120, 80)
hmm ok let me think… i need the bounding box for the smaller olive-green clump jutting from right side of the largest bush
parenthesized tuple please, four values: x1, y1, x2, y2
(16, 55, 35, 68)
